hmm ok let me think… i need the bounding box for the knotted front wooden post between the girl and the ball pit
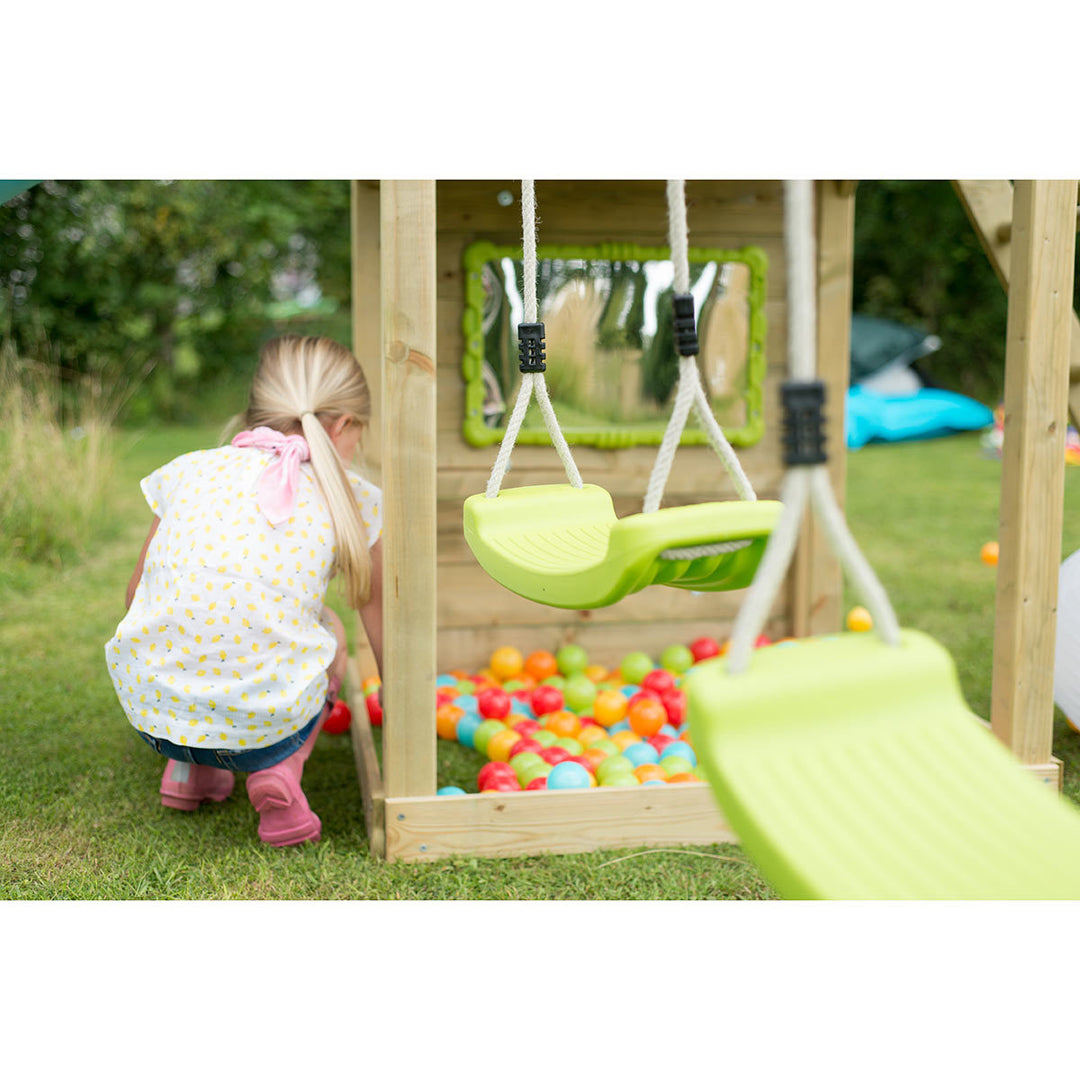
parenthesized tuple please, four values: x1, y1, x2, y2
(380, 180, 436, 798)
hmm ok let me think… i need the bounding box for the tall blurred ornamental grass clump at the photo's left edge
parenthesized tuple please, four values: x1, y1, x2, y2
(0, 340, 116, 580)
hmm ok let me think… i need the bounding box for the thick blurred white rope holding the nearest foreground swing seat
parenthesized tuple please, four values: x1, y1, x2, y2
(727, 180, 900, 675)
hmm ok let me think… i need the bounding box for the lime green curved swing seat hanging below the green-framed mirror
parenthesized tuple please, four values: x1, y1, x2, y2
(463, 484, 781, 609)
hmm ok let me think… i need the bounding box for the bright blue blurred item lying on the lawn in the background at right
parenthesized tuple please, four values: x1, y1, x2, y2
(846, 387, 994, 450)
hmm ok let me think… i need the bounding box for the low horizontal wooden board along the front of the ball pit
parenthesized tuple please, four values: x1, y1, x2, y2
(386, 783, 737, 862)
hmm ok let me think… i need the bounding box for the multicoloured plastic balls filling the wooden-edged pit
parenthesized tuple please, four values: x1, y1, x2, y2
(429, 635, 797, 794)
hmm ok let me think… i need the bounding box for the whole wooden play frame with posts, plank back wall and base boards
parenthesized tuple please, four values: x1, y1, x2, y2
(348, 180, 1077, 861)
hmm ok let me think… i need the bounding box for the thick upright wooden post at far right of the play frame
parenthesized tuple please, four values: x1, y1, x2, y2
(990, 180, 1077, 765)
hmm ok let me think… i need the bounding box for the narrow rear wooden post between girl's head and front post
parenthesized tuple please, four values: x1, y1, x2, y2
(350, 180, 382, 487)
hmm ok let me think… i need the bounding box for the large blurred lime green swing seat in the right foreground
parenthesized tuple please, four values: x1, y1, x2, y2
(686, 631, 1080, 900)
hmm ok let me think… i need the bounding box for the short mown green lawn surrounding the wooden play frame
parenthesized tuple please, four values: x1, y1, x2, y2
(0, 429, 1080, 900)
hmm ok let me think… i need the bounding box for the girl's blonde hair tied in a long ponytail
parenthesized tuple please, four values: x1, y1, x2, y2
(242, 335, 372, 610)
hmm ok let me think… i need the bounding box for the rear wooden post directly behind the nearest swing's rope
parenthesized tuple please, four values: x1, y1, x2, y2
(792, 180, 855, 637)
